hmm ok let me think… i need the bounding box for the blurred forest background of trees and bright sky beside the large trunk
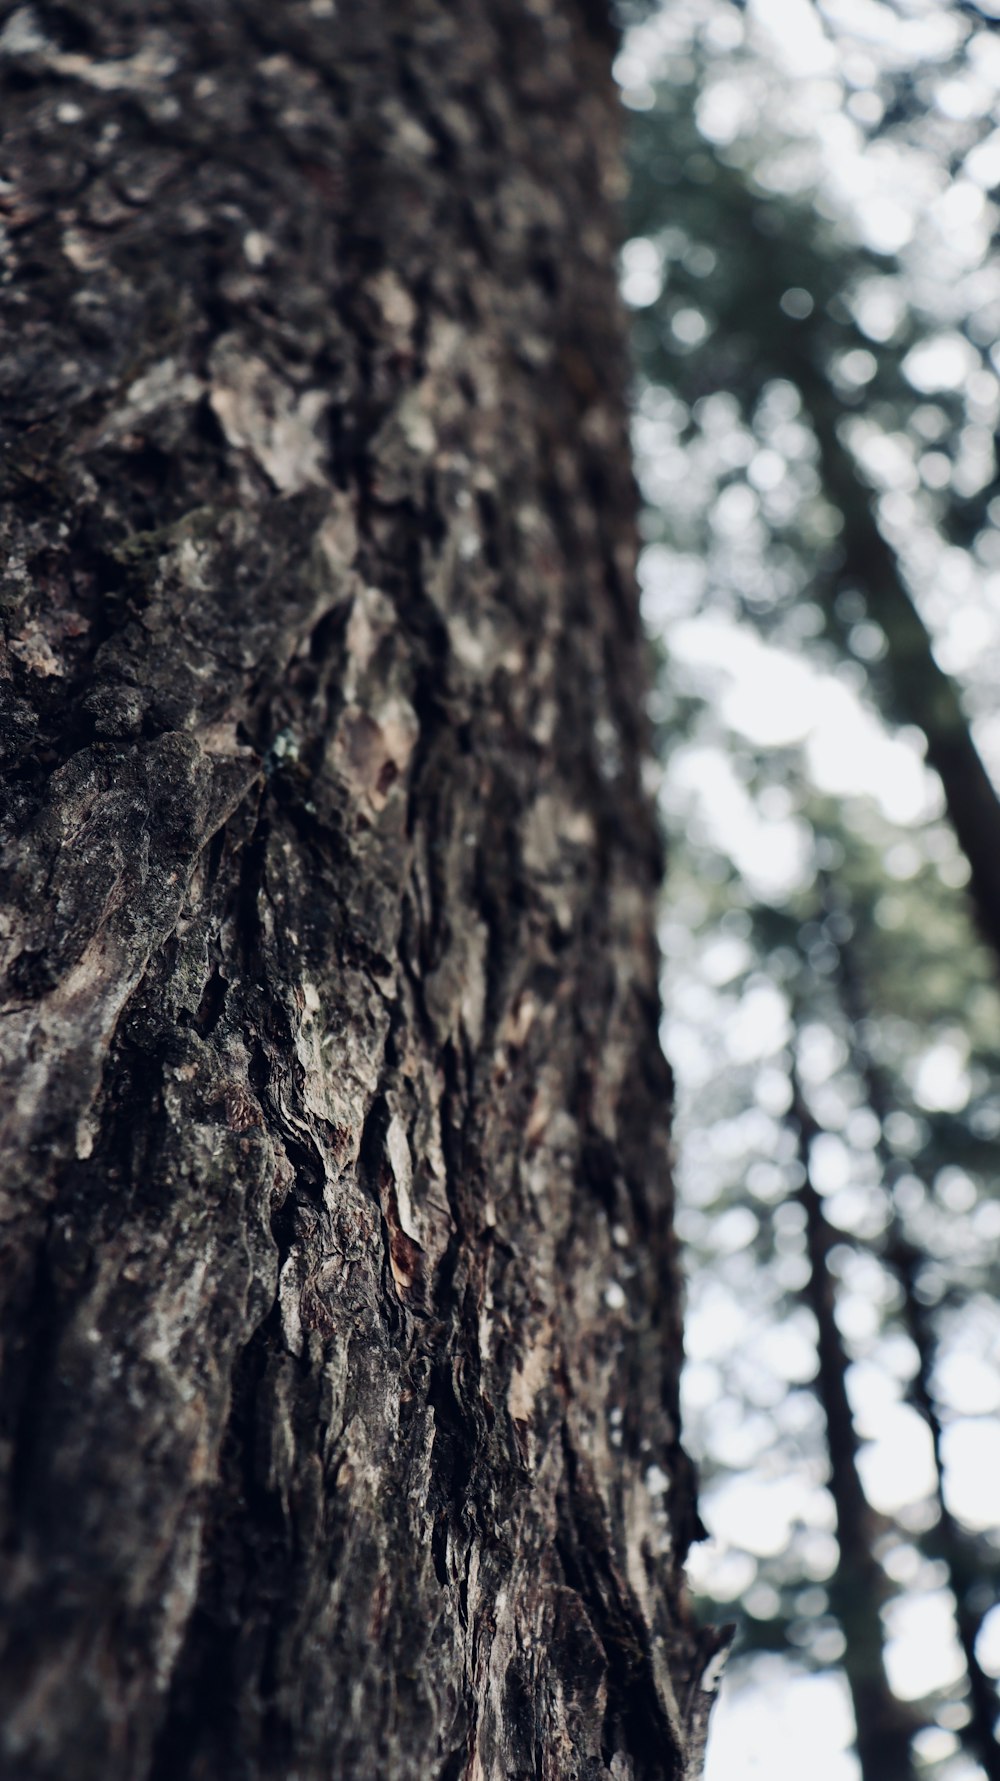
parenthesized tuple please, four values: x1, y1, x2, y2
(617, 0, 1000, 1781)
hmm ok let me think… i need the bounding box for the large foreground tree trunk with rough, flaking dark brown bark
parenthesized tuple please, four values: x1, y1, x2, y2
(0, 0, 718, 1781)
